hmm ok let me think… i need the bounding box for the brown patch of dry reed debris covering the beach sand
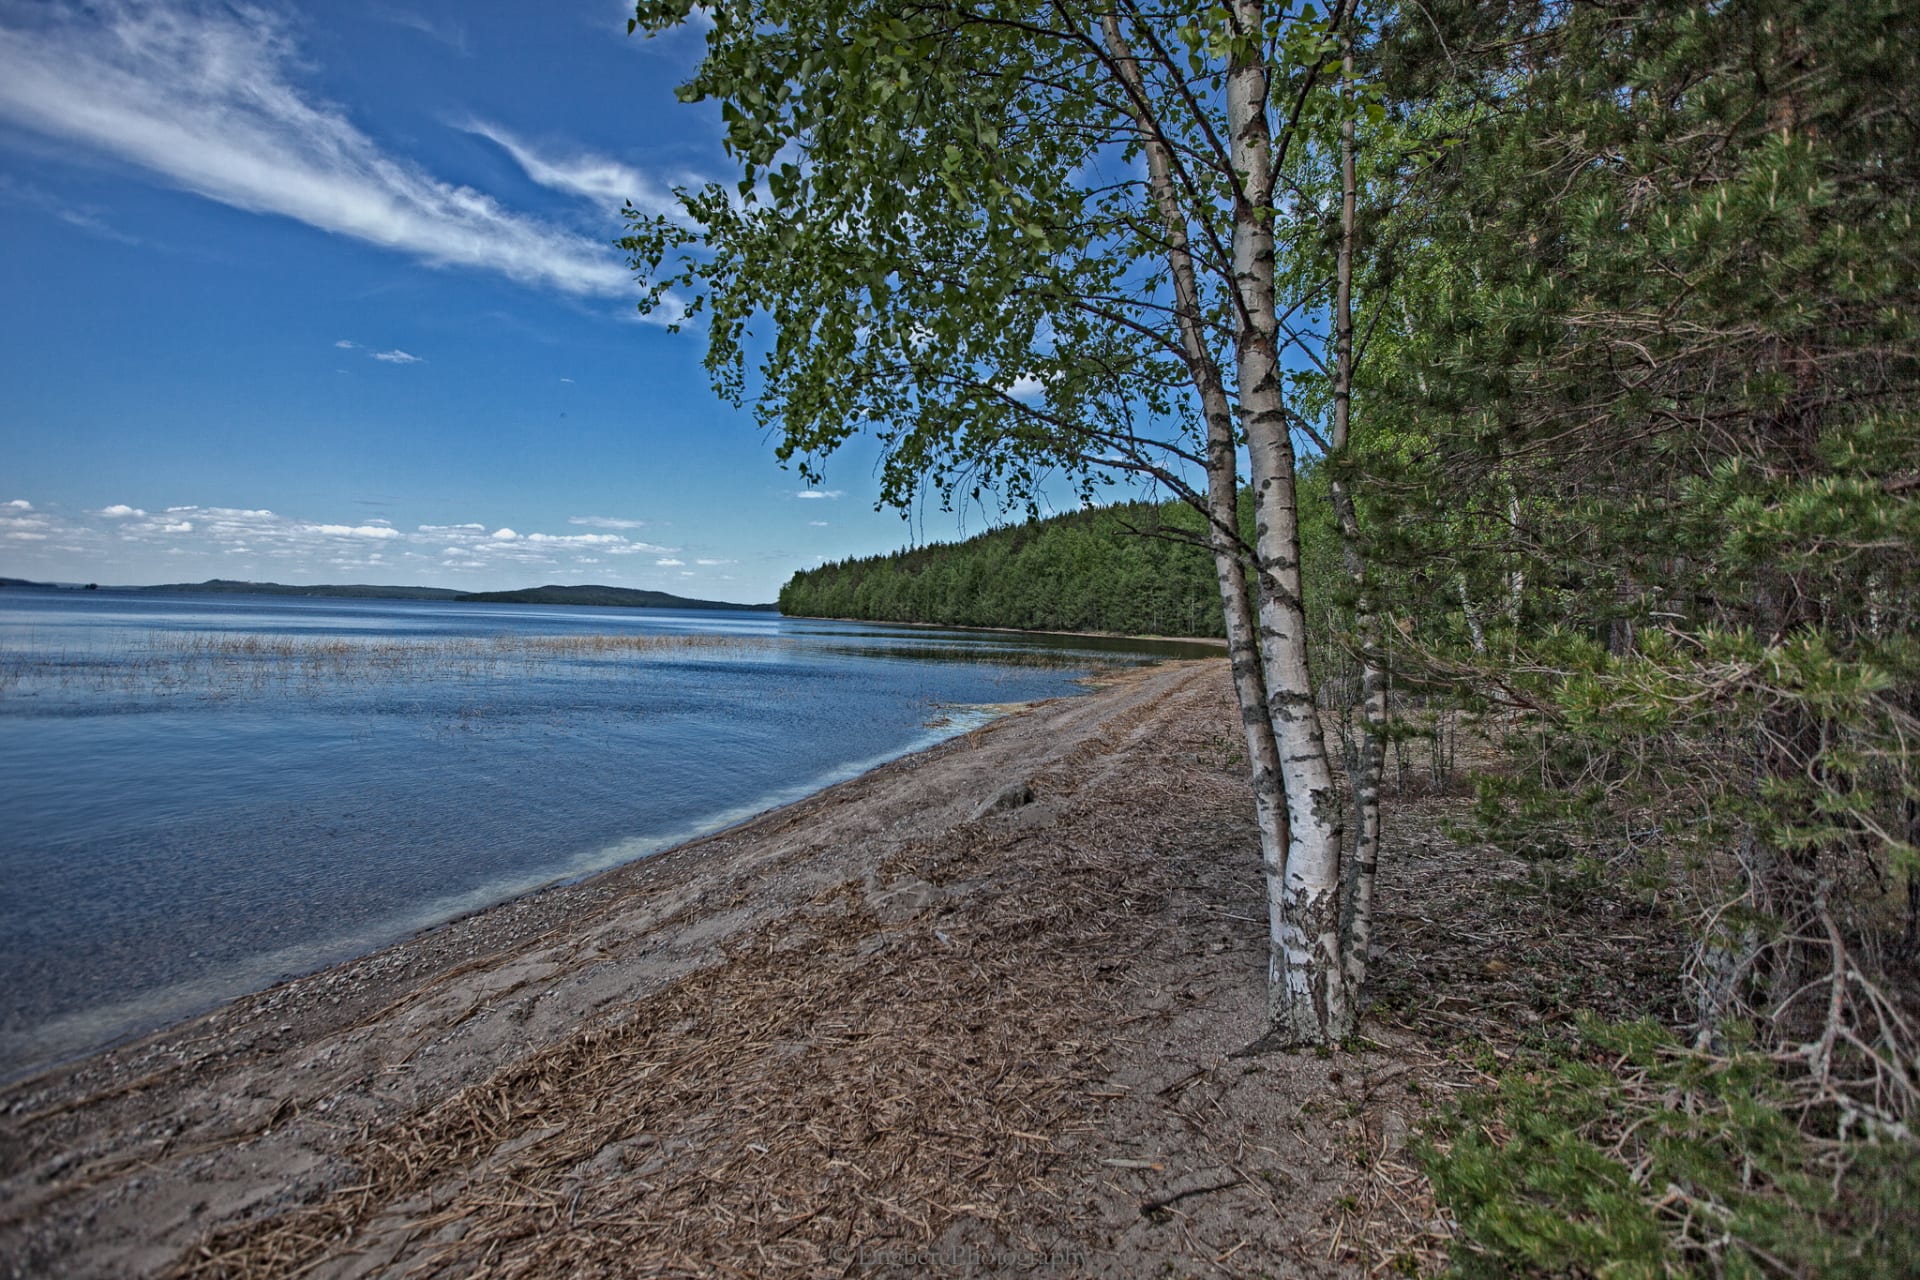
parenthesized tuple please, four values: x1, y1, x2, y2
(175, 856, 1121, 1276)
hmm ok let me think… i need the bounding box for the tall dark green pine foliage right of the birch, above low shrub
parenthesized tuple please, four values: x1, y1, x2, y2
(1356, 0, 1920, 1066)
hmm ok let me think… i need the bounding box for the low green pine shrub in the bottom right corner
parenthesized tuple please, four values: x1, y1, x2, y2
(1421, 1021, 1920, 1280)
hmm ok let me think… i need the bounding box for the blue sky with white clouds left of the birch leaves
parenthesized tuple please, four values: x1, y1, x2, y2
(0, 0, 1067, 601)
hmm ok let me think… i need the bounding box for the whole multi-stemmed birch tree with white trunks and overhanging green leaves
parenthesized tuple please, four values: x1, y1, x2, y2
(624, 0, 1377, 1042)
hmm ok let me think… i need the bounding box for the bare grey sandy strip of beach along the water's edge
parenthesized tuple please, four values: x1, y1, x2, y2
(0, 662, 1198, 1274)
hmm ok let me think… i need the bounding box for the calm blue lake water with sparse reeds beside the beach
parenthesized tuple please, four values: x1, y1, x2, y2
(0, 587, 1200, 1077)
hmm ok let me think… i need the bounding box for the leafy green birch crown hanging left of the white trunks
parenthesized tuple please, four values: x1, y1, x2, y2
(624, 0, 1219, 507)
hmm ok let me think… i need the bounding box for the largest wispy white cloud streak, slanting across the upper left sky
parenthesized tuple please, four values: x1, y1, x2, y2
(0, 0, 636, 297)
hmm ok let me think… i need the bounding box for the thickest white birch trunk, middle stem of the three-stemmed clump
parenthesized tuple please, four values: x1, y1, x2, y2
(1227, 0, 1354, 1044)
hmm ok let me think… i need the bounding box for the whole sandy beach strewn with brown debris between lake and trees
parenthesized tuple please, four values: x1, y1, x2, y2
(0, 660, 1681, 1276)
